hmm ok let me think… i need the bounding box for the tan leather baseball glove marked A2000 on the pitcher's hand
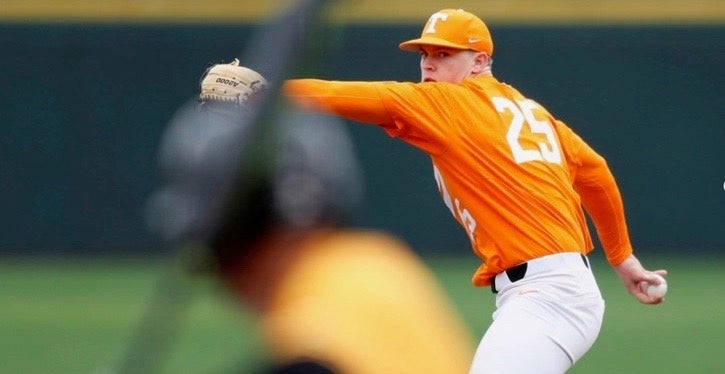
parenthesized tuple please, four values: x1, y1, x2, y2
(199, 58, 267, 105)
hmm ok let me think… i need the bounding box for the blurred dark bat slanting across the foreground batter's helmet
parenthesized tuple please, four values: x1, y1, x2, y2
(111, 0, 327, 373)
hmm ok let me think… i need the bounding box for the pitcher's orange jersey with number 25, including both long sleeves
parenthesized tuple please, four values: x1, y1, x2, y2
(284, 76, 632, 286)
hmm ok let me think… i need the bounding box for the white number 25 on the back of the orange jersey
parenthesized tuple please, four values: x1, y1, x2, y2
(493, 97, 561, 164)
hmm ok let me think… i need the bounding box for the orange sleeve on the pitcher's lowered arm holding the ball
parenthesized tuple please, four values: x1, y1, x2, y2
(557, 121, 632, 266)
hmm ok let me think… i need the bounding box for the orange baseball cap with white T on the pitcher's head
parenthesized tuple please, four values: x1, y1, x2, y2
(400, 9, 493, 56)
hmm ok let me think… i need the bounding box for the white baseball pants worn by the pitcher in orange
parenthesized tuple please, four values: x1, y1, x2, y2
(470, 253, 604, 374)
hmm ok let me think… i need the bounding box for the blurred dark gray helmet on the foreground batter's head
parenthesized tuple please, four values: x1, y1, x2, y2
(146, 103, 362, 248)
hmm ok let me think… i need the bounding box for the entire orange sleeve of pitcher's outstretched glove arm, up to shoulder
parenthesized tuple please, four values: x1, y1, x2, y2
(283, 79, 450, 154)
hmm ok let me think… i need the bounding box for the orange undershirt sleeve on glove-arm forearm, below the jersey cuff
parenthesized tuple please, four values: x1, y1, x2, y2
(282, 79, 393, 127)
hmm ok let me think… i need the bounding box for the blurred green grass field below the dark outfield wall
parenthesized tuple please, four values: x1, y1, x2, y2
(0, 255, 725, 374)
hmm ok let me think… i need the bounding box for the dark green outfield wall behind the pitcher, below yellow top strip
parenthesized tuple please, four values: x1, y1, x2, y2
(0, 23, 725, 254)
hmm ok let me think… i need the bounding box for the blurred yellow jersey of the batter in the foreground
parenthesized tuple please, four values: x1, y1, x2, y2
(255, 230, 475, 374)
